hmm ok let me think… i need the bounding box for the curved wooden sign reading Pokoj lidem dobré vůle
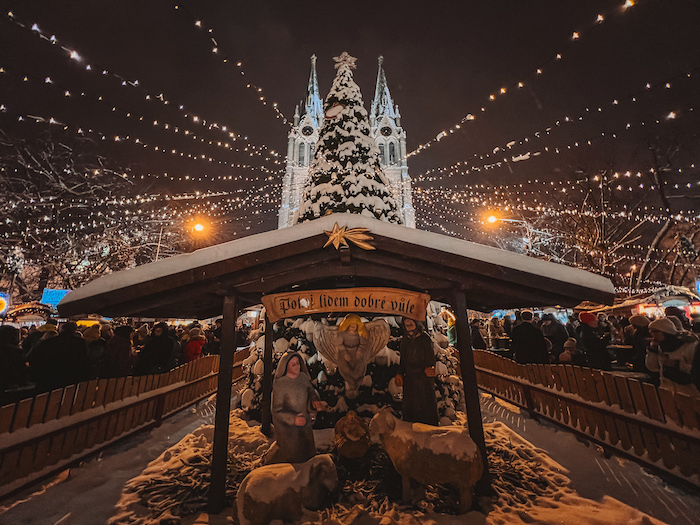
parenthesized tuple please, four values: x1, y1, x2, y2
(262, 288, 430, 322)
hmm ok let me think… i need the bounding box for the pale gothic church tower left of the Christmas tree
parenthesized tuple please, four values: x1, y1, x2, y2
(277, 55, 323, 228)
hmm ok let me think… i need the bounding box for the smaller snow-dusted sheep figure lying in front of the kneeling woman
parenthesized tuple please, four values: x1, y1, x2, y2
(236, 454, 338, 525)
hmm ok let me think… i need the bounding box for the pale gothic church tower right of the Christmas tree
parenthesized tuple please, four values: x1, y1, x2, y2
(369, 56, 416, 228)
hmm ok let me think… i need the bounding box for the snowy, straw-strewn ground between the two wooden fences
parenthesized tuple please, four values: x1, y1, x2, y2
(0, 395, 700, 525)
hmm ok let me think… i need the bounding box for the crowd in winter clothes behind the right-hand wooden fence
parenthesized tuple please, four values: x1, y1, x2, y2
(472, 307, 700, 397)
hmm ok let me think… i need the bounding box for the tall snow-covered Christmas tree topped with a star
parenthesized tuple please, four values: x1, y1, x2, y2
(296, 53, 402, 224)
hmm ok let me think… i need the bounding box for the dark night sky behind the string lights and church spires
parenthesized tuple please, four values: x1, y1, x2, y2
(0, 0, 700, 240)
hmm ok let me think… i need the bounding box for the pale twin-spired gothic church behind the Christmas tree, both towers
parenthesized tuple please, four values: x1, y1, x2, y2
(278, 55, 416, 228)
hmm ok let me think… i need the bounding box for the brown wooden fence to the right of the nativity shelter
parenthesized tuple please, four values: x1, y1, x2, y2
(474, 350, 700, 487)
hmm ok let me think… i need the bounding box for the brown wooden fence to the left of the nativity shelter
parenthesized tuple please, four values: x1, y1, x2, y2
(0, 353, 247, 497)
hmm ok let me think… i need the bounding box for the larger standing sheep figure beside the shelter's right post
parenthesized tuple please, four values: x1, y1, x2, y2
(369, 408, 484, 514)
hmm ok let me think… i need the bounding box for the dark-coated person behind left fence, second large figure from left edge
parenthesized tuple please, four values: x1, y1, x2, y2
(29, 322, 89, 392)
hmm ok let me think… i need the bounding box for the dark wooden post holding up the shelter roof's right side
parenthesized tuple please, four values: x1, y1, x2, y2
(452, 290, 492, 496)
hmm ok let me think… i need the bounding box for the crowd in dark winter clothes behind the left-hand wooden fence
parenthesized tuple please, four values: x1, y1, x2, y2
(0, 319, 252, 404)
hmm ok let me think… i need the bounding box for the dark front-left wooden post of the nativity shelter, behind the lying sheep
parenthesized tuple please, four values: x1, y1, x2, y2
(208, 295, 238, 513)
